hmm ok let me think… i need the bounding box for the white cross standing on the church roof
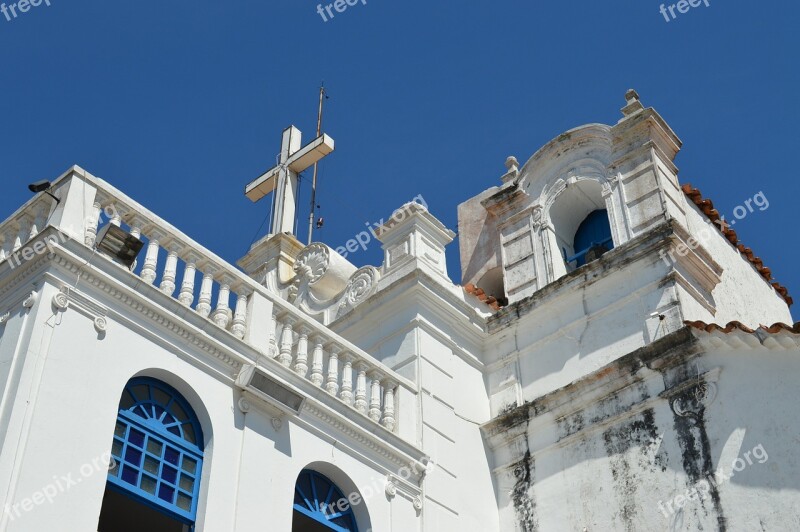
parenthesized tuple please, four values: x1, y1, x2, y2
(244, 126, 334, 234)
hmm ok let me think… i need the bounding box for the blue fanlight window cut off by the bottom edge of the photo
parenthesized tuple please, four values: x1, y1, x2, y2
(292, 469, 358, 532)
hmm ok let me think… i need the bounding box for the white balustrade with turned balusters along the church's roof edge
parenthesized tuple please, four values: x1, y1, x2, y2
(0, 168, 418, 432)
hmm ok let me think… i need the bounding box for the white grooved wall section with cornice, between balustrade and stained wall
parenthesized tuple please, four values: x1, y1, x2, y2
(332, 273, 498, 531)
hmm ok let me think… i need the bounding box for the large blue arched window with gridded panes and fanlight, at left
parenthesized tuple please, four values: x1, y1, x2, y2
(108, 378, 203, 525)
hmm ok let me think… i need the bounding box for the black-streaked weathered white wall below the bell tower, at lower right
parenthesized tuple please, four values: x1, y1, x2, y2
(485, 329, 800, 531)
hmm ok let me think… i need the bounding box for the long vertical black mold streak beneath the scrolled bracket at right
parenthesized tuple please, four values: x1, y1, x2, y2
(671, 383, 727, 532)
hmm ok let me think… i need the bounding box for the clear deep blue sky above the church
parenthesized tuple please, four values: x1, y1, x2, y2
(0, 0, 800, 320)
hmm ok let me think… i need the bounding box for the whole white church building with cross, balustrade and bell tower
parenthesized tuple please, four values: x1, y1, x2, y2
(0, 91, 800, 532)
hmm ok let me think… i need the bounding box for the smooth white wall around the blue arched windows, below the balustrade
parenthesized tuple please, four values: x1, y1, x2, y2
(0, 276, 420, 532)
